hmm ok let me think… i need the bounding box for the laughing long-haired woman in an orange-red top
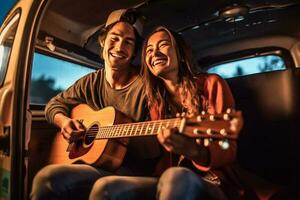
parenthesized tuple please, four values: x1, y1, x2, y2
(92, 27, 244, 200)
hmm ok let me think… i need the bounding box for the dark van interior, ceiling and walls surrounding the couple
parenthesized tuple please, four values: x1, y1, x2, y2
(27, 0, 300, 198)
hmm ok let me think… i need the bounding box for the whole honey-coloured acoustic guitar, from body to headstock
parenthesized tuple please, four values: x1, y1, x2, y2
(50, 104, 243, 170)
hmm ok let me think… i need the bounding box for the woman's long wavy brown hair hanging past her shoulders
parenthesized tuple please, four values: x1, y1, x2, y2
(141, 26, 201, 118)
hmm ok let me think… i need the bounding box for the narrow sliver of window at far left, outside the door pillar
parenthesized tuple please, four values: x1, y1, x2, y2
(0, 14, 20, 86)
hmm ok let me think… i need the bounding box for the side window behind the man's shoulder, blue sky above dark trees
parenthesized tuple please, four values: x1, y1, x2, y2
(30, 52, 95, 104)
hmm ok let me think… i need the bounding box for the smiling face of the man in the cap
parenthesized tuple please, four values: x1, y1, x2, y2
(101, 22, 135, 70)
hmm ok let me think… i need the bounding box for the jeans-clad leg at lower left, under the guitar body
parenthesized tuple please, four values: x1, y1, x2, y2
(30, 164, 112, 200)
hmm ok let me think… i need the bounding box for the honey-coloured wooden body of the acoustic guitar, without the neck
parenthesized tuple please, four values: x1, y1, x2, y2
(50, 104, 131, 171)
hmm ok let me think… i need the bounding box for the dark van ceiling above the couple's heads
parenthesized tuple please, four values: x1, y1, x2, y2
(38, 0, 300, 65)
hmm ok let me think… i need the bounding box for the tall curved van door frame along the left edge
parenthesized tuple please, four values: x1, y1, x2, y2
(0, 0, 49, 199)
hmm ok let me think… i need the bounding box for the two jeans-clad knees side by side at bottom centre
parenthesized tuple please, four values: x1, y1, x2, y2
(90, 167, 227, 200)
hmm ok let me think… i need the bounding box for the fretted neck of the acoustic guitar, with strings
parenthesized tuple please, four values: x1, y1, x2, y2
(94, 118, 184, 139)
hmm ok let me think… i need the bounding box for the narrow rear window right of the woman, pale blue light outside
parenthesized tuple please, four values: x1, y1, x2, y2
(207, 55, 286, 78)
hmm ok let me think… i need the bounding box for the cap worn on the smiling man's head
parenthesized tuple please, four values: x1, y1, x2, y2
(105, 9, 144, 36)
